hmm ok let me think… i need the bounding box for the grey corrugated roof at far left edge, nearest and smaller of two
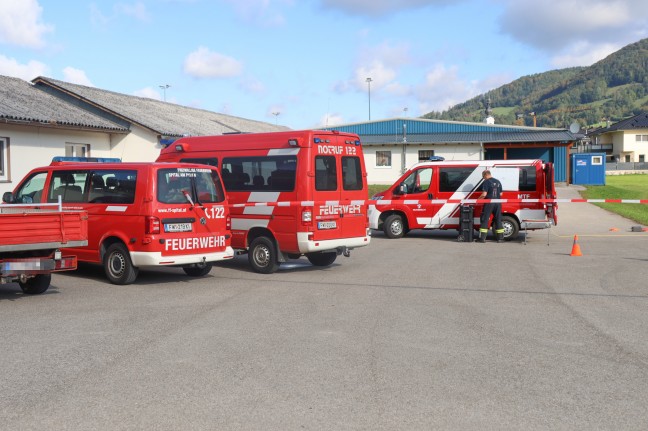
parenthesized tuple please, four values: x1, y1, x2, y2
(0, 75, 128, 132)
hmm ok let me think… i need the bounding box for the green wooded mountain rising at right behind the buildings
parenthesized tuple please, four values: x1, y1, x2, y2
(423, 39, 648, 127)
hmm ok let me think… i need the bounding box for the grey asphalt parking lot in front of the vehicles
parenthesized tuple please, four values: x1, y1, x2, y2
(0, 186, 648, 430)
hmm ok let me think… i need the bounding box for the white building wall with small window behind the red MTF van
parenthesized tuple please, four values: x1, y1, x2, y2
(363, 144, 481, 185)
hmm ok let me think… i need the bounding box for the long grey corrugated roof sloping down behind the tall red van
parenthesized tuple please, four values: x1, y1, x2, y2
(33, 77, 289, 136)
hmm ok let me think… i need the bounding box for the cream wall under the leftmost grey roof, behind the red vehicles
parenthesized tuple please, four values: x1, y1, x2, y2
(0, 124, 111, 195)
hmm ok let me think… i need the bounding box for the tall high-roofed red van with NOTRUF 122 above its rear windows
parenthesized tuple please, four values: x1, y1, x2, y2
(158, 130, 370, 274)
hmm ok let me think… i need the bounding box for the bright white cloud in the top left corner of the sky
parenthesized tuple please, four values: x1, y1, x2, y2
(0, 0, 54, 48)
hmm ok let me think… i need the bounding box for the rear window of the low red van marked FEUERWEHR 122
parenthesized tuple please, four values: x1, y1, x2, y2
(157, 168, 225, 204)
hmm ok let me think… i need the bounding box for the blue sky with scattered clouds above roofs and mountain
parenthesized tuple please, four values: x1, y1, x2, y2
(0, 0, 648, 129)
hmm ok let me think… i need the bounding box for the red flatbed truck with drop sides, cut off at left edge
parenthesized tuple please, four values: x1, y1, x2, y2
(0, 198, 88, 295)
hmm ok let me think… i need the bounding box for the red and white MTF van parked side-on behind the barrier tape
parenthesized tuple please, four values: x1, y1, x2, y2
(369, 160, 558, 240)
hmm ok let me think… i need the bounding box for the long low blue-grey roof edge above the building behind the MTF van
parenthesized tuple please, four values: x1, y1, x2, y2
(360, 129, 574, 145)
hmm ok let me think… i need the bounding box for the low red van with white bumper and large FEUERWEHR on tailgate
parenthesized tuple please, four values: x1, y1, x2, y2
(6, 157, 234, 284)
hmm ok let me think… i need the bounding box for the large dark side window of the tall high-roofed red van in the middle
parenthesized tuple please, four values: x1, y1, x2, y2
(221, 156, 297, 192)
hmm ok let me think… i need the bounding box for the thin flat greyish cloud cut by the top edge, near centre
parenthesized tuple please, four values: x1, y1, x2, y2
(320, 0, 456, 16)
